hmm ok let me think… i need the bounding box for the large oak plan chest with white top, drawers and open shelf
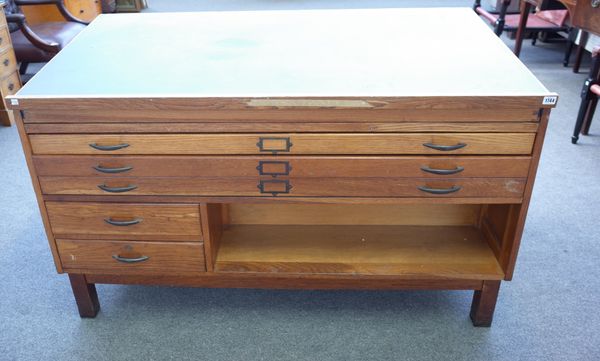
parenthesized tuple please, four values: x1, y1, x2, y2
(9, 9, 557, 325)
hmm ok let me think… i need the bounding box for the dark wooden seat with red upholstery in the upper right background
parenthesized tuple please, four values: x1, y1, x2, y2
(473, 0, 569, 41)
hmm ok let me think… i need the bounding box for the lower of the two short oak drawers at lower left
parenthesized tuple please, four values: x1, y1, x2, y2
(56, 239, 206, 275)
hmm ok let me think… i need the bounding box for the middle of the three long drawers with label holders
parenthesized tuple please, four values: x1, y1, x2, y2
(33, 155, 531, 178)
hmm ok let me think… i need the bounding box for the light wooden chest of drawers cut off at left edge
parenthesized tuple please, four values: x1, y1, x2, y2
(0, 3, 21, 126)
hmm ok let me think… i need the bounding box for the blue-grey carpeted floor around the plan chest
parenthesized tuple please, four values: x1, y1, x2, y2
(0, 0, 600, 361)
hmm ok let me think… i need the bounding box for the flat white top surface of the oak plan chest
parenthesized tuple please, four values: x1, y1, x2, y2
(15, 8, 551, 99)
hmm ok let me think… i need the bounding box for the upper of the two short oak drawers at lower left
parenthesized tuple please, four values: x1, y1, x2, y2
(46, 202, 202, 241)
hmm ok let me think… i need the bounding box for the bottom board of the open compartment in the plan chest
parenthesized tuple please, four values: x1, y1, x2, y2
(215, 225, 504, 279)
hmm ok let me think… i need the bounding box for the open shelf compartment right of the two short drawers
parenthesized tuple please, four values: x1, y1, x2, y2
(205, 204, 504, 280)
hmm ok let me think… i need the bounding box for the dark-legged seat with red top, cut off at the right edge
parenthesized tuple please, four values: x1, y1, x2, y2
(571, 47, 600, 144)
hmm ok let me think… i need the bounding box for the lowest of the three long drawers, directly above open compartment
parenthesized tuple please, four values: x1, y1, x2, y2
(40, 177, 525, 197)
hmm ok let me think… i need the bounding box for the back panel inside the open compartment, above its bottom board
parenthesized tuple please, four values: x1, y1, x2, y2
(227, 203, 481, 226)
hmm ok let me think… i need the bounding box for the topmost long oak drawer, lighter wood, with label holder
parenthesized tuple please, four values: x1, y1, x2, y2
(30, 133, 535, 155)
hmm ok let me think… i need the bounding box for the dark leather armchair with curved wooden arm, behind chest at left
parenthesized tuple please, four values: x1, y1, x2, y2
(5, 0, 88, 74)
